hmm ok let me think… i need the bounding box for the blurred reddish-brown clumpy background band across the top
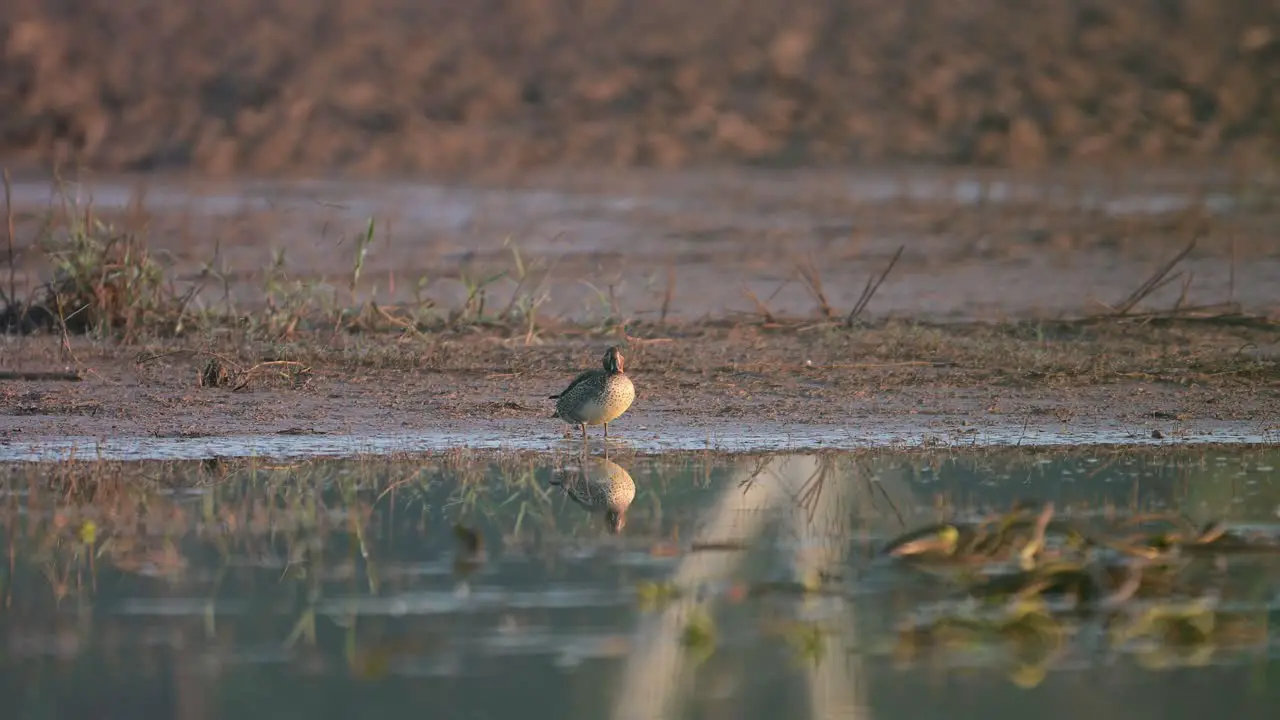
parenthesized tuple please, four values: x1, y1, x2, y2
(0, 0, 1280, 174)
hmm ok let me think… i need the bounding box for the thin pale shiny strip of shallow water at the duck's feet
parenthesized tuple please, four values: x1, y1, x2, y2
(0, 418, 1280, 462)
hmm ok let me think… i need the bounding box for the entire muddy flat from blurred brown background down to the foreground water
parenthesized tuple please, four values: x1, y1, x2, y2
(0, 172, 1280, 456)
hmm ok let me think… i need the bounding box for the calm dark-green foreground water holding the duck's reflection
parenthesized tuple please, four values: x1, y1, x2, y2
(0, 448, 1280, 720)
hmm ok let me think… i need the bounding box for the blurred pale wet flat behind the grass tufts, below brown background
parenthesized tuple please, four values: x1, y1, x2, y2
(13, 168, 1280, 324)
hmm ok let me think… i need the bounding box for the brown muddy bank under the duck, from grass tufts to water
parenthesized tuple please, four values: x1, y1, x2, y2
(0, 319, 1280, 459)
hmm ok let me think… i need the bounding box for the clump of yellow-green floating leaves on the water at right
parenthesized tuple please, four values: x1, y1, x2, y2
(881, 503, 1280, 687)
